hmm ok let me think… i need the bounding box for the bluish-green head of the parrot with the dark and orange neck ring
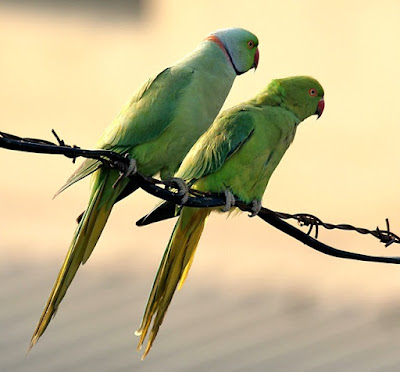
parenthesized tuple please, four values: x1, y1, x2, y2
(207, 28, 259, 75)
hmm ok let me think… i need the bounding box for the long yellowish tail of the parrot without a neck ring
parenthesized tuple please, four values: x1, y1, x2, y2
(135, 208, 211, 359)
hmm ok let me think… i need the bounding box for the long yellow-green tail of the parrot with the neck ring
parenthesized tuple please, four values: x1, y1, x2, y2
(28, 171, 123, 351)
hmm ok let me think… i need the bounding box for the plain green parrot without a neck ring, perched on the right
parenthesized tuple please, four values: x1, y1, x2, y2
(136, 76, 324, 358)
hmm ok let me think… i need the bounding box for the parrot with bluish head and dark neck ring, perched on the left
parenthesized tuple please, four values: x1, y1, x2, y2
(29, 28, 259, 349)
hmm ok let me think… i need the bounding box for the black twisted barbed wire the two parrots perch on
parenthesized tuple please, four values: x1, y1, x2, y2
(0, 130, 400, 264)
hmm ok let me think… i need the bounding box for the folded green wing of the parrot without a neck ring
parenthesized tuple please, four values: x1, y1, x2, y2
(176, 105, 254, 184)
